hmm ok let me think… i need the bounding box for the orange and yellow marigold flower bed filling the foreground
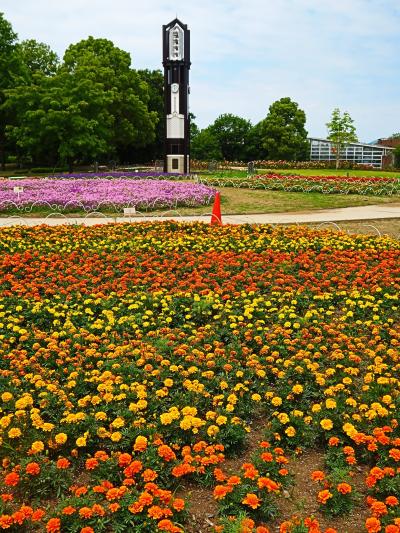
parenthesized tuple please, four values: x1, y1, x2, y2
(0, 222, 400, 533)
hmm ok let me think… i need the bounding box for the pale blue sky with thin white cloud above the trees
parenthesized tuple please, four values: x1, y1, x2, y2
(0, 0, 400, 142)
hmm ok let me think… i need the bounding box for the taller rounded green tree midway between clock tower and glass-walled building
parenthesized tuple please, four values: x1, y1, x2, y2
(260, 97, 308, 161)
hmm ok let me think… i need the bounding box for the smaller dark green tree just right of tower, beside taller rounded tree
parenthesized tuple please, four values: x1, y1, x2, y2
(208, 113, 251, 161)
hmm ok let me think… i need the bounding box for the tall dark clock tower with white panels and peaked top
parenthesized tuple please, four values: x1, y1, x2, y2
(163, 18, 190, 174)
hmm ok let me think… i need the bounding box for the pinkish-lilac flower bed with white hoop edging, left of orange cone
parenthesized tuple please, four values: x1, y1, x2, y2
(0, 178, 215, 211)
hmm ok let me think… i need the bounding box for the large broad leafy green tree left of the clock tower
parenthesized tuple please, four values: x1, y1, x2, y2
(9, 37, 157, 168)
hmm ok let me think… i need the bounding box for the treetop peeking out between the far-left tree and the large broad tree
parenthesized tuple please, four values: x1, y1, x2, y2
(18, 39, 60, 76)
